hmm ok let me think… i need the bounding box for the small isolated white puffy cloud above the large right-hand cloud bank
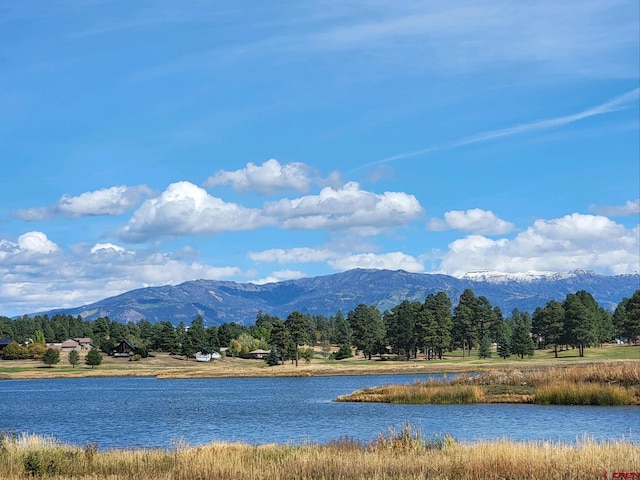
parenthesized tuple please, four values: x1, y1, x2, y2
(427, 208, 514, 235)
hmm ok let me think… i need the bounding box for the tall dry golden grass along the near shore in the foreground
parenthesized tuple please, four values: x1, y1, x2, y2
(0, 426, 640, 480)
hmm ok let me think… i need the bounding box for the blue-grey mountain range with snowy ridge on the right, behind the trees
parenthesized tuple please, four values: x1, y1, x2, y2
(32, 269, 640, 325)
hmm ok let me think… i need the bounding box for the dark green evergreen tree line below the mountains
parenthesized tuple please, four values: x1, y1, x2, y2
(0, 289, 640, 364)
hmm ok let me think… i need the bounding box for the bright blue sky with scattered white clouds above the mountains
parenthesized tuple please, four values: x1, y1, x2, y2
(0, 0, 640, 316)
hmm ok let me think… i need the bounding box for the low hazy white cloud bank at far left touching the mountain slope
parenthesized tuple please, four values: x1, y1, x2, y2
(0, 232, 246, 314)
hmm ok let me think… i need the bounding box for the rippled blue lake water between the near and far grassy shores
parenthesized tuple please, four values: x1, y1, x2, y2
(0, 375, 640, 449)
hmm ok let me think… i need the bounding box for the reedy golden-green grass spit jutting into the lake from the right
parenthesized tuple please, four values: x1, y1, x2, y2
(337, 361, 640, 405)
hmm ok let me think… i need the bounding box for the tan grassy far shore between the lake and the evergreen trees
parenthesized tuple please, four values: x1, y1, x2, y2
(0, 345, 640, 380)
